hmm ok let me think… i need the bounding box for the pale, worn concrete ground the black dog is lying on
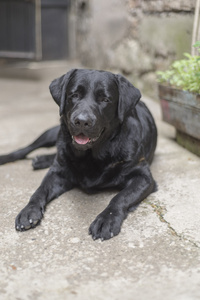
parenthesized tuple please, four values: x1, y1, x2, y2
(0, 62, 200, 300)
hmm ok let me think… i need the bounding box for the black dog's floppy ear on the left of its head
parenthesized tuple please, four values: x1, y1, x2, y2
(49, 69, 76, 115)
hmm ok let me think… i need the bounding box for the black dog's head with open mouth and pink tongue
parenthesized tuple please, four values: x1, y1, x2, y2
(50, 69, 141, 150)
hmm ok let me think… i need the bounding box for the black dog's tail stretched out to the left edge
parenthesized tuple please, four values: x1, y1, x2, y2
(0, 126, 60, 165)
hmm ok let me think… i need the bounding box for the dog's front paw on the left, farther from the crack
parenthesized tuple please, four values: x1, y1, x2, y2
(15, 204, 44, 231)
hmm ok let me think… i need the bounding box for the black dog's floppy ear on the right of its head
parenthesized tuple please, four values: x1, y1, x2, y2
(115, 74, 141, 123)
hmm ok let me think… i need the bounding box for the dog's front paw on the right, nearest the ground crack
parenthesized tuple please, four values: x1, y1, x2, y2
(89, 209, 124, 241)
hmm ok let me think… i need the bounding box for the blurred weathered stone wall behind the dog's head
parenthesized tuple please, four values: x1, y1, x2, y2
(76, 0, 196, 95)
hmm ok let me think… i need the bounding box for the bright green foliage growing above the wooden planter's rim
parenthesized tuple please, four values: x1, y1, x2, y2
(157, 41, 200, 94)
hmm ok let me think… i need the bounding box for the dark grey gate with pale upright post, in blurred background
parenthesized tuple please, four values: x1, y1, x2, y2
(0, 0, 69, 60)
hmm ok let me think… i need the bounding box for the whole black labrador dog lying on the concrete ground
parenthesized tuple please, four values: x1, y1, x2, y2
(0, 69, 157, 240)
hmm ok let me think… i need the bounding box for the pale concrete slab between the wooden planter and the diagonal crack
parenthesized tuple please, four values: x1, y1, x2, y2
(147, 99, 200, 247)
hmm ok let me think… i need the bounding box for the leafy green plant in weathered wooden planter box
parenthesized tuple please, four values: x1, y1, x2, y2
(157, 41, 200, 156)
